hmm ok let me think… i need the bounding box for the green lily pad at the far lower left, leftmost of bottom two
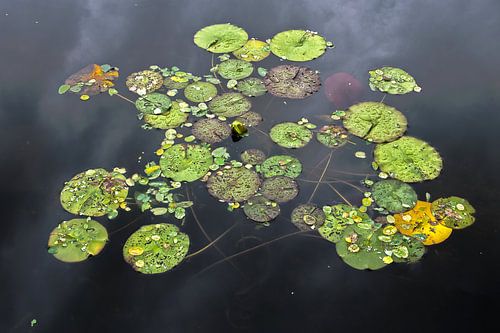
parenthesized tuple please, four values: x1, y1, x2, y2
(48, 219, 108, 262)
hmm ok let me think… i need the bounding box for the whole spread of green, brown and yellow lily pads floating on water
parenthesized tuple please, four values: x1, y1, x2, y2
(48, 23, 475, 274)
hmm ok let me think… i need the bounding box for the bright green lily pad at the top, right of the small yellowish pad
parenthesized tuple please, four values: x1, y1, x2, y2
(270, 30, 326, 61)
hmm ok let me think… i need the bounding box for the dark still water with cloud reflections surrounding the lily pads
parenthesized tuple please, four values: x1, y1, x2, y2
(0, 0, 500, 333)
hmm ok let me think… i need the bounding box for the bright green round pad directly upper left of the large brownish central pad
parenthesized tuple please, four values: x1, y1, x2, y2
(160, 144, 213, 182)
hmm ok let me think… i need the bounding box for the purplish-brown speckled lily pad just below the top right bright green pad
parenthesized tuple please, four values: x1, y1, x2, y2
(264, 65, 321, 99)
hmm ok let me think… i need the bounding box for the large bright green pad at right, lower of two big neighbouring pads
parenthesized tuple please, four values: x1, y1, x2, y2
(374, 136, 443, 183)
